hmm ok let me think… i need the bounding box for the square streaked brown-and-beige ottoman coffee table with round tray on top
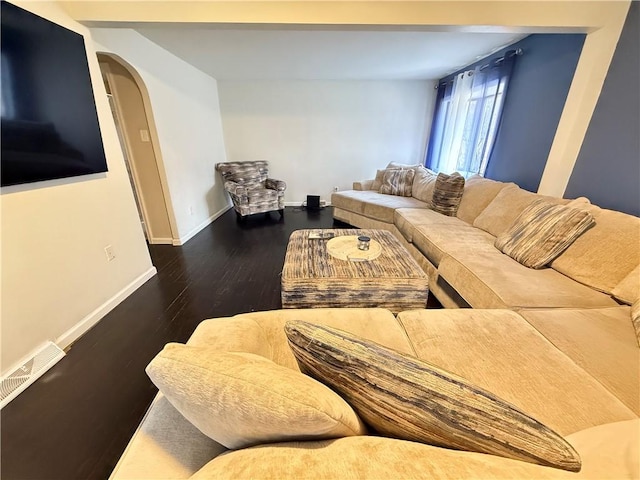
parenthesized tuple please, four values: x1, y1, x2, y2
(282, 229, 429, 313)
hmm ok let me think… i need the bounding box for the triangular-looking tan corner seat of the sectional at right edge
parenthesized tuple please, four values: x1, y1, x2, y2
(520, 306, 640, 415)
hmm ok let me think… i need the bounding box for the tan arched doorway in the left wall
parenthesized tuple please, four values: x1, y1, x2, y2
(98, 53, 177, 244)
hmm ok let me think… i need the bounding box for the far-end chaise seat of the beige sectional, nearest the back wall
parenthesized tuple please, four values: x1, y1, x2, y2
(331, 190, 427, 223)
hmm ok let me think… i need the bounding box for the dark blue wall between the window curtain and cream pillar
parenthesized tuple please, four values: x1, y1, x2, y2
(485, 34, 585, 192)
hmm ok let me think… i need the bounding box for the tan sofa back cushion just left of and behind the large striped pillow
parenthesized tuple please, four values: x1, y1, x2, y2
(473, 184, 568, 237)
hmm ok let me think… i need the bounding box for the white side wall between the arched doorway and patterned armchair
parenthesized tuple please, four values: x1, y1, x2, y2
(91, 28, 229, 244)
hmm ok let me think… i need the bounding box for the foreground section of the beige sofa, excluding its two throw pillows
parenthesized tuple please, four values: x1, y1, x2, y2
(112, 307, 640, 480)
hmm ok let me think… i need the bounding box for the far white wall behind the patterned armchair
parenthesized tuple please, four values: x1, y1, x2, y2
(218, 81, 435, 205)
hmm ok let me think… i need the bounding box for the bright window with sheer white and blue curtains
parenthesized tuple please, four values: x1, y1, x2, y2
(426, 50, 516, 177)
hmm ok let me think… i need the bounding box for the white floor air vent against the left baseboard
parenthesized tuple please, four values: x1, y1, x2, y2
(0, 342, 64, 409)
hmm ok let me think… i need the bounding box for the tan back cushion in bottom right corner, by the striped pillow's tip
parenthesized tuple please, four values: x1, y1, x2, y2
(567, 419, 640, 480)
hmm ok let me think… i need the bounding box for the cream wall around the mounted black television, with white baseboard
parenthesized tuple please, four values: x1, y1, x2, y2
(0, 1, 155, 374)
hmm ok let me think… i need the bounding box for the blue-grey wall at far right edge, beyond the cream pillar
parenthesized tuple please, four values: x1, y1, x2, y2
(565, 2, 640, 216)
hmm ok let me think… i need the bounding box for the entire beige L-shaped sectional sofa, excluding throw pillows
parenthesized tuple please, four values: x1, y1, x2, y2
(111, 164, 640, 480)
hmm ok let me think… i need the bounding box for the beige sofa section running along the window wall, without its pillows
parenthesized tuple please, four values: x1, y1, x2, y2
(331, 167, 640, 310)
